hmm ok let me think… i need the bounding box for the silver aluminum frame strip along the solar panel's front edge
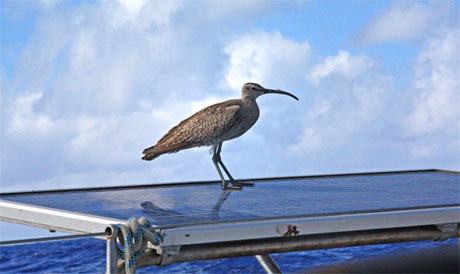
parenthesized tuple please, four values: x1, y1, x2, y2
(162, 206, 460, 247)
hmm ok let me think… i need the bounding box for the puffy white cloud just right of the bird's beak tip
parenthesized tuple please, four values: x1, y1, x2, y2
(292, 50, 393, 153)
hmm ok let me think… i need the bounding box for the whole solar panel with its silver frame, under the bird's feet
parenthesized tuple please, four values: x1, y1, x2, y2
(0, 170, 460, 272)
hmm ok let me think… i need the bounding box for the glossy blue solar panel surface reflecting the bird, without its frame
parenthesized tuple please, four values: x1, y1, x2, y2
(1, 171, 460, 227)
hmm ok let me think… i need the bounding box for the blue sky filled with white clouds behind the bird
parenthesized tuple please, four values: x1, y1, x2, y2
(0, 0, 460, 239)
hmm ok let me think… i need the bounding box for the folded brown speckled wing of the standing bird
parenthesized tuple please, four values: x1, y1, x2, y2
(143, 100, 241, 154)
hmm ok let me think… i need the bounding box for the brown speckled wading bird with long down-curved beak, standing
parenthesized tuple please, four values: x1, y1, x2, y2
(142, 82, 299, 190)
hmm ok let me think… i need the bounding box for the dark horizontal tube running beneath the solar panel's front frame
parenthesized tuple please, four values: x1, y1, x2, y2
(132, 226, 459, 267)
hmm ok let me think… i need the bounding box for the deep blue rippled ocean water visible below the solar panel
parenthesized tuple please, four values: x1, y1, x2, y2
(0, 239, 457, 274)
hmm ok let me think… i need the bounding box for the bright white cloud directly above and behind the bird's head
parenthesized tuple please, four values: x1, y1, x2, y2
(225, 31, 310, 90)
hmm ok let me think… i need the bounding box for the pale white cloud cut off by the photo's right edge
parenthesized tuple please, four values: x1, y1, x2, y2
(404, 29, 460, 137)
